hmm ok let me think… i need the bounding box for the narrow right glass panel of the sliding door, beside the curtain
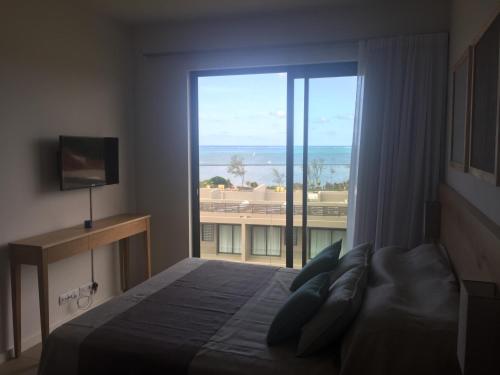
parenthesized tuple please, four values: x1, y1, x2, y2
(306, 76, 357, 259)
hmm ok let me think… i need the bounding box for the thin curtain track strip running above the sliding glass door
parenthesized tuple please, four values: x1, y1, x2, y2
(142, 31, 448, 58)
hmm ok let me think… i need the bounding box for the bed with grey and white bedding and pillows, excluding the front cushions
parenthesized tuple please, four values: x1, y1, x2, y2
(39, 238, 458, 375)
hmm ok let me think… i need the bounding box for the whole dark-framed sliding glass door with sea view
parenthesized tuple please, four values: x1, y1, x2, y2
(191, 63, 357, 268)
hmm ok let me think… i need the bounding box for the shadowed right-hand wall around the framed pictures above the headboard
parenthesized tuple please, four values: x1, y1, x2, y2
(446, 0, 500, 225)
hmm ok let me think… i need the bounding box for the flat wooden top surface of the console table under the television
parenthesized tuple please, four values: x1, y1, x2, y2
(9, 214, 151, 249)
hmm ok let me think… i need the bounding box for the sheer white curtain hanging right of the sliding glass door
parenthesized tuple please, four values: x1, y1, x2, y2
(349, 34, 448, 248)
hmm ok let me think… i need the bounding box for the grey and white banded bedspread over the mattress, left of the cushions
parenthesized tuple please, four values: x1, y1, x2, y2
(39, 258, 338, 375)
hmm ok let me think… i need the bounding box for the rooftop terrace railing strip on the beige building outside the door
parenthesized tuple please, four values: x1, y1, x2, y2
(200, 202, 347, 216)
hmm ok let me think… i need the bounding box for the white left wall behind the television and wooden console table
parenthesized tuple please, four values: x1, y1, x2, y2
(0, 0, 135, 356)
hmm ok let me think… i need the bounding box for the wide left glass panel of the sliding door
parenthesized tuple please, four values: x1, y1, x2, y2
(196, 72, 287, 267)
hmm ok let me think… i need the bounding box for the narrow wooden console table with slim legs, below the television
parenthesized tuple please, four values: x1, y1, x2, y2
(9, 214, 151, 357)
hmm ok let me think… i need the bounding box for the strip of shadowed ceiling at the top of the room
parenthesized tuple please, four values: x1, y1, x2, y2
(84, 0, 378, 23)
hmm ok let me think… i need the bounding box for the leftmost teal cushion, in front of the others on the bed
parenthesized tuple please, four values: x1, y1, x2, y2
(267, 272, 330, 345)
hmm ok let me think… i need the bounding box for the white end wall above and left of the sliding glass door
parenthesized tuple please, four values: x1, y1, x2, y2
(134, 1, 449, 272)
